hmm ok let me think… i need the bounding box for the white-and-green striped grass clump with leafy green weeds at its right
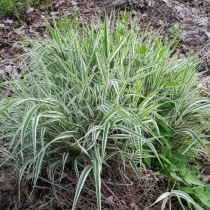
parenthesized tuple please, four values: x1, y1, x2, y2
(0, 15, 210, 210)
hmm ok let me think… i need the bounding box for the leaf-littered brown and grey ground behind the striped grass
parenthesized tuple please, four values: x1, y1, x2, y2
(0, 0, 210, 74)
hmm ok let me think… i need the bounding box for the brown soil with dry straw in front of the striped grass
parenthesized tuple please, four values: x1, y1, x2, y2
(0, 162, 166, 210)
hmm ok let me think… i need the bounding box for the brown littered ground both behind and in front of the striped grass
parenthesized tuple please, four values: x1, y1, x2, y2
(0, 0, 210, 210)
